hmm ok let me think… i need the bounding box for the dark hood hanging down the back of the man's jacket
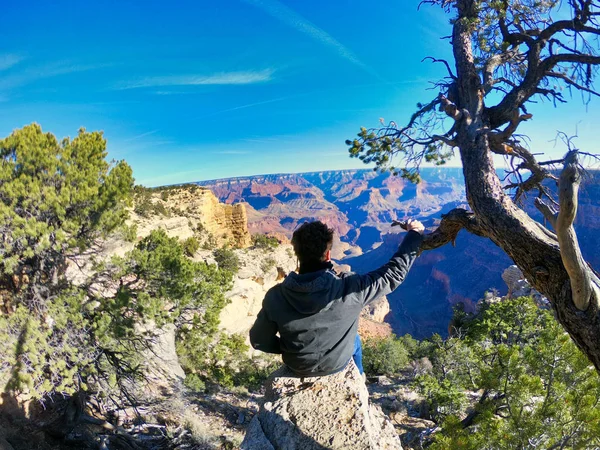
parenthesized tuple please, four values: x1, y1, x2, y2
(281, 270, 337, 315)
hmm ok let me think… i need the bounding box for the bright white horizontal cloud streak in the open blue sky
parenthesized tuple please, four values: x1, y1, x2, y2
(118, 69, 275, 92)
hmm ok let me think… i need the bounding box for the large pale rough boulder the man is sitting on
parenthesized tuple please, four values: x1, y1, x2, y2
(241, 361, 402, 450)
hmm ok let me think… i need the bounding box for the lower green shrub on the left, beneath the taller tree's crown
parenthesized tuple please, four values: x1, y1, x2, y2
(0, 230, 231, 398)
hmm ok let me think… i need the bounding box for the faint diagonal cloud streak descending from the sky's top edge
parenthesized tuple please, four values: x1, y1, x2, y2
(243, 0, 382, 79)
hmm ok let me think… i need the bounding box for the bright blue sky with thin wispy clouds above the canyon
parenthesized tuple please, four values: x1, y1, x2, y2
(0, 0, 600, 186)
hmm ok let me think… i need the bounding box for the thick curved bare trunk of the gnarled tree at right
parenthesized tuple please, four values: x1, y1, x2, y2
(452, 0, 600, 372)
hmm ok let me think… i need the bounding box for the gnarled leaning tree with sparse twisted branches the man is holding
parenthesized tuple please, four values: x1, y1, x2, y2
(346, 0, 600, 371)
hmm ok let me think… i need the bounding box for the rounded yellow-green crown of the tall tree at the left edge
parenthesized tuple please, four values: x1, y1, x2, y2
(0, 124, 133, 283)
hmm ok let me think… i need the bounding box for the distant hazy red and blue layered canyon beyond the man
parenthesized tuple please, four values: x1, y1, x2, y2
(198, 168, 600, 338)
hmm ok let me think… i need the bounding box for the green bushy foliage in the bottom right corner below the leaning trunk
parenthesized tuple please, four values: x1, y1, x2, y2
(415, 298, 600, 450)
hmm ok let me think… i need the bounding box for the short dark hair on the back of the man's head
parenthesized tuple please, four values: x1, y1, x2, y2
(292, 220, 333, 263)
